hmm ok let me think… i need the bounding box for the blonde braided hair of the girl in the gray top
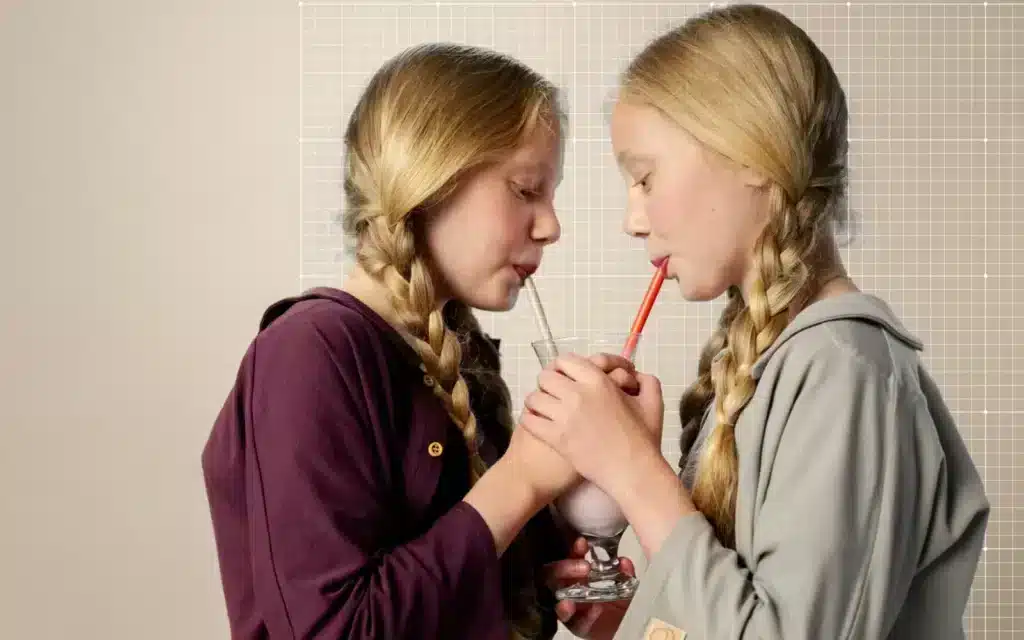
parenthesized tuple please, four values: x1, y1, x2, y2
(622, 4, 848, 546)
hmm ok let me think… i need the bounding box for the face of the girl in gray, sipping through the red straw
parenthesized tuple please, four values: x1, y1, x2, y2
(611, 101, 765, 301)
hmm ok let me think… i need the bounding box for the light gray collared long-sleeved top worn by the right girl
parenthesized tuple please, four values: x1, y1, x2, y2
(615, 293, 989, 640)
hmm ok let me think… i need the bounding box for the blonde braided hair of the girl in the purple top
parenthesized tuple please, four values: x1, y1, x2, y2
(342, 43, 563, 636)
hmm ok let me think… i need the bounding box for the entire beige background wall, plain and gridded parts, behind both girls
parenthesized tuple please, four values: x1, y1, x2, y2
(0, 0, 1024, 640)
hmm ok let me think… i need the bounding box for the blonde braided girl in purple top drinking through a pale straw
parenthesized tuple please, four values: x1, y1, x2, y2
(203, 44, 635, 640)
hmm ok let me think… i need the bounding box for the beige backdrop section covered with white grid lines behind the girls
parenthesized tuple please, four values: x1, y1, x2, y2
(298, 0, 1024, 640)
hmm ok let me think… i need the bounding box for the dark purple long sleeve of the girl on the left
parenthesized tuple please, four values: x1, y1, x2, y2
(240, 309, 507, 640)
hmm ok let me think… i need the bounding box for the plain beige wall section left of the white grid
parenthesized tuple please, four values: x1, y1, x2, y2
(0, 0, 299, 640)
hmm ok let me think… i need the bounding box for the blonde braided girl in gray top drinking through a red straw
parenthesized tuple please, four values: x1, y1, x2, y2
(521, 5, 989, 640)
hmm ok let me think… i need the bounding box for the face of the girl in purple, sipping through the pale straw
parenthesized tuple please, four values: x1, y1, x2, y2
(426, 126, 561, 311)
